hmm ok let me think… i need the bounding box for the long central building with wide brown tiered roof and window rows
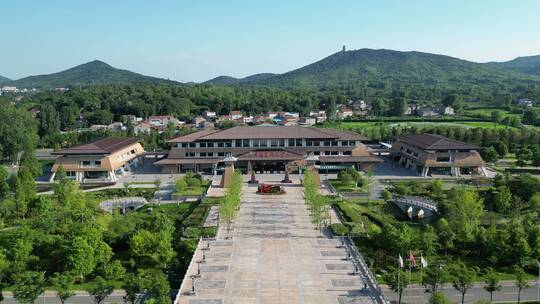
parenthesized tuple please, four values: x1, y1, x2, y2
(155, 126, 382, 173)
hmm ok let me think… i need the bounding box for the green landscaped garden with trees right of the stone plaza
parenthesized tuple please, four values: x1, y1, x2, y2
(329, 175, 540, 287)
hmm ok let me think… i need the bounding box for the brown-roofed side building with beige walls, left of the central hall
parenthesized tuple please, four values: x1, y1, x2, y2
(50, 137, 144, 182)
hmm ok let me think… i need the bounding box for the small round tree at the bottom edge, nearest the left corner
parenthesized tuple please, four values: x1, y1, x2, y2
(13, 271, 45, 304)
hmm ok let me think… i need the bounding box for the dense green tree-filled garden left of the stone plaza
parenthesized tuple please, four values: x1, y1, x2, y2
(0, 159, 220, 303)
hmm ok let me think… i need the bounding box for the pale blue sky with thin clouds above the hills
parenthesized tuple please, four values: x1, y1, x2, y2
(0, 0, 540, 82)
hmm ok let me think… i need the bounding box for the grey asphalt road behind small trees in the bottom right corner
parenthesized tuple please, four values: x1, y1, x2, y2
(383, 282, 538, 303)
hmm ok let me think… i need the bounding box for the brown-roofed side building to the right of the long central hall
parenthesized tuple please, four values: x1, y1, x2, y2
(390, 134, 486, 176)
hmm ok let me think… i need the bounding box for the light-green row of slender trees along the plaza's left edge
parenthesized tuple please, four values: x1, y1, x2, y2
(219, 170, 243, 237)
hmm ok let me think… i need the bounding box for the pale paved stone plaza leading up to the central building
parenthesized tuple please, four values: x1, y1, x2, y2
(178, 178, 376, 304)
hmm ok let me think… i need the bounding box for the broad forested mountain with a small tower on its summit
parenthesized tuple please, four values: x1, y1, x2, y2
(247, 49, 540, 88)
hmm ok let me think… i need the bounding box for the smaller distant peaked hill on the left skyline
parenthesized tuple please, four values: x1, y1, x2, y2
(10, 60, 176, 88)
